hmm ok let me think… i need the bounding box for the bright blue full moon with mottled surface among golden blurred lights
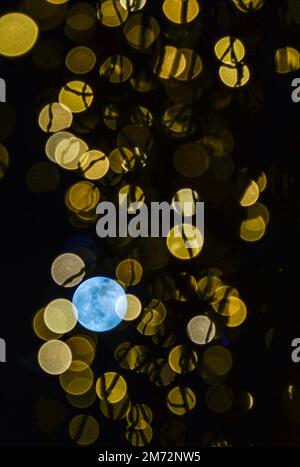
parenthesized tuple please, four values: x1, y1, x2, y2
(73, 277, 128, 332)
